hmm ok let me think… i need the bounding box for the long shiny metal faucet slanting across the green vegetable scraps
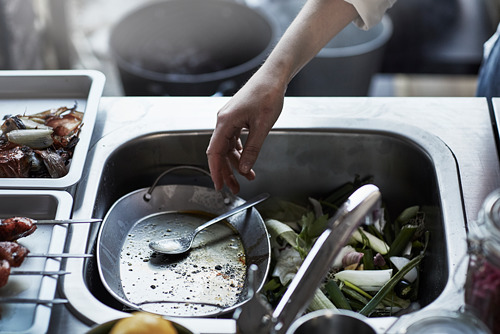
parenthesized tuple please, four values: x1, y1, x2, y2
(234, 184, 381, 334)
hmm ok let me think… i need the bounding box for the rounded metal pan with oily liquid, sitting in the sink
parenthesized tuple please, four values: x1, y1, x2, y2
(97, 179, 270, 317)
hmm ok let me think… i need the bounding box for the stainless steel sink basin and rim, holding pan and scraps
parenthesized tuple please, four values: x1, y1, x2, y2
(62, 119, 466, 333)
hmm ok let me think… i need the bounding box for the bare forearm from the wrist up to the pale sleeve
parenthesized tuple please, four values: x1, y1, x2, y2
(259, 0, 358, 87)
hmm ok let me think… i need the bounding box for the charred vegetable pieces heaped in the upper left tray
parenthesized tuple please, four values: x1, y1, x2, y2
(0, 104, 83, 178)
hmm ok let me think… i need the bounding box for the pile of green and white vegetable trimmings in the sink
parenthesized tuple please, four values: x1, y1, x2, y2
(259, 177, 428, 316)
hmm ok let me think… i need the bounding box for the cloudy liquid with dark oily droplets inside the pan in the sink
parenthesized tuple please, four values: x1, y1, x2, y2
(120, 212, 246, 316)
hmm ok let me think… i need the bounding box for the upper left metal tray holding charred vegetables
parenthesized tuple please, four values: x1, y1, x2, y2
(0, 70, 105, 190)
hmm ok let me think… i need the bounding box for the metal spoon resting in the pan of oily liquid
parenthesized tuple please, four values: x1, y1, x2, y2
(149, 193, 269, 254)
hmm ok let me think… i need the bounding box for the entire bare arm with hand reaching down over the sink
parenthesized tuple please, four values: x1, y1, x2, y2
(207, 0, 395, 194)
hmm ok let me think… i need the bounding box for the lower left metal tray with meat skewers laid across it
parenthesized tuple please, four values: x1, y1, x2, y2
(0, 190, 73, 334)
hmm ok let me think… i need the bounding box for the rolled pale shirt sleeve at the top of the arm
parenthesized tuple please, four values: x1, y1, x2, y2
(344, 0, 396, 30)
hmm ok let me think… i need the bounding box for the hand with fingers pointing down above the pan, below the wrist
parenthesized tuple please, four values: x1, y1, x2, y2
(206, 74, 284, 194)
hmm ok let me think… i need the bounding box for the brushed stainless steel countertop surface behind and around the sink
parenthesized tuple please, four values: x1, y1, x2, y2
(50, 97, 500, 333)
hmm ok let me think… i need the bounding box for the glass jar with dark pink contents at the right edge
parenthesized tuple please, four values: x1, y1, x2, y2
(465, 189, 500, 333)
